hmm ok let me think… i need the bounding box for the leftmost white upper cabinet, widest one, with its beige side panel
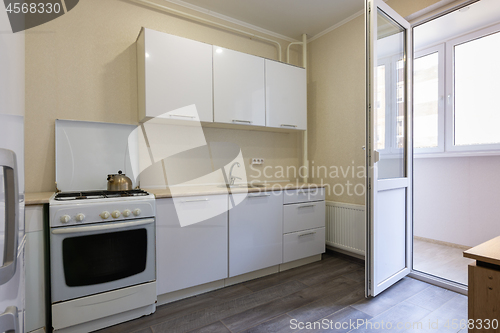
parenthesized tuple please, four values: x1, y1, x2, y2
(137, 28, 213, 122)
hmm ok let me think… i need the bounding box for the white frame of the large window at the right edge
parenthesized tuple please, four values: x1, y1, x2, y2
(444, 23, 500, 154)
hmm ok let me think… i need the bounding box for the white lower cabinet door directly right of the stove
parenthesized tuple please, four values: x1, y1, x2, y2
(156, 195, 228, 295)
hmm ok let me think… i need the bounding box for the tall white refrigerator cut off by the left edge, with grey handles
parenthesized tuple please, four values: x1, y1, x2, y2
(0, 2, 25, 333)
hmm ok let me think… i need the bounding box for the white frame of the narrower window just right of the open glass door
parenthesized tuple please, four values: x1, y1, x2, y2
(413, 43, 446, 154)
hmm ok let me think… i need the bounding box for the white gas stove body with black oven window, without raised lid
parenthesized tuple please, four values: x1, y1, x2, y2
(49, 190, 156, 332)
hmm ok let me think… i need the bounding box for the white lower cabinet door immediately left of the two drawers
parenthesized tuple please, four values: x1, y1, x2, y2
(229, 192, 283, 277)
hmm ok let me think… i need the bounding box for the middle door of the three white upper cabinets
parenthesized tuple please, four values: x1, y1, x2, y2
(213, 46, 266, 126)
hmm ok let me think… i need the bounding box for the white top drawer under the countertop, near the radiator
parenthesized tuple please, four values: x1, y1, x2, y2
(283, 201, 325, 234)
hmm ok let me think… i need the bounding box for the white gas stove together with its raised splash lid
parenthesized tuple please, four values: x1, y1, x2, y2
(49, 120, 156, 333)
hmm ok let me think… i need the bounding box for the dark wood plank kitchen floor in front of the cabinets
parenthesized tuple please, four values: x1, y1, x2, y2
(98, 253, 467, 333)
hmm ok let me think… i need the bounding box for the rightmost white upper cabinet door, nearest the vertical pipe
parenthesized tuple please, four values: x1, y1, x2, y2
(265, 59, 307, 130)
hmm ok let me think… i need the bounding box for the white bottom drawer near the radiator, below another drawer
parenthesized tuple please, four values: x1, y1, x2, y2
(283, 228, 325, 263)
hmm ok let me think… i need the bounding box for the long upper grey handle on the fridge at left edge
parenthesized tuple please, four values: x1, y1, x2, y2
(0, 149, 19, 284)
